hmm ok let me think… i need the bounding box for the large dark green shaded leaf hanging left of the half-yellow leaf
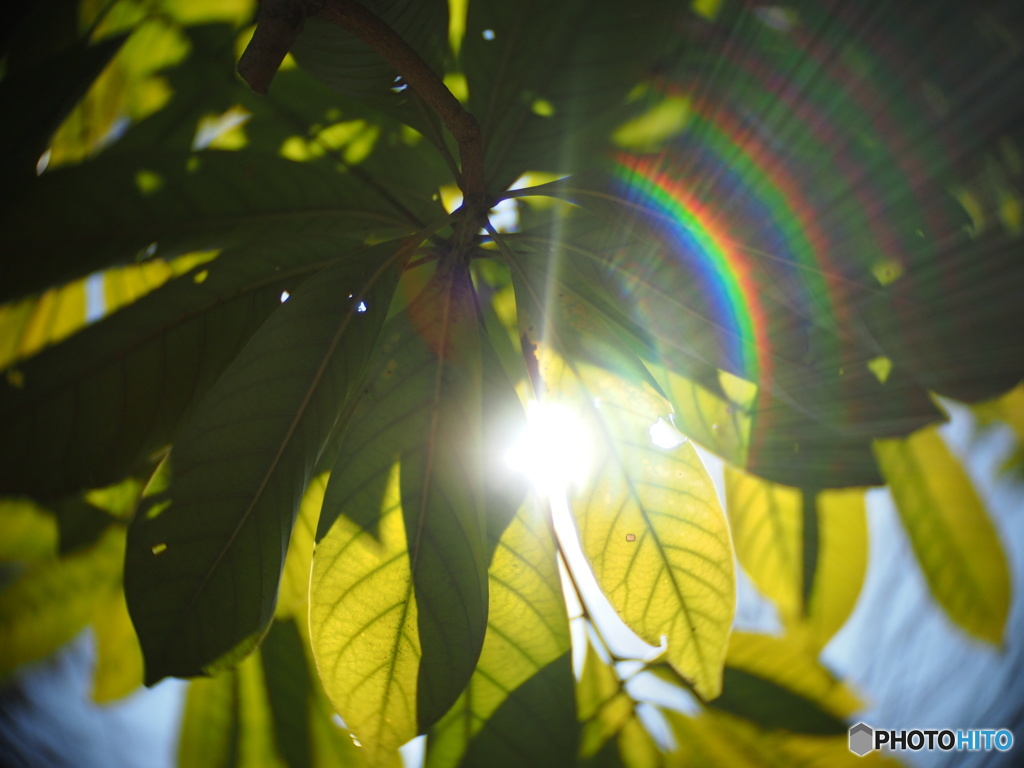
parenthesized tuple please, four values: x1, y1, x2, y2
(125, 240, 403, 683)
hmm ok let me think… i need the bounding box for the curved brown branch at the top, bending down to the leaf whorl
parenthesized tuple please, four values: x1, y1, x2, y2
(239, 0, 489, 205)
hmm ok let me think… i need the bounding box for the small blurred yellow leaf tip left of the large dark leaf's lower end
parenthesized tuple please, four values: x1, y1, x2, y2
(92, 584, 142, 703)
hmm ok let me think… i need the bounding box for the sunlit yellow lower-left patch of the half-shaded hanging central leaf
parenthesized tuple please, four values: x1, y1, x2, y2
(309, 465, 423, 764)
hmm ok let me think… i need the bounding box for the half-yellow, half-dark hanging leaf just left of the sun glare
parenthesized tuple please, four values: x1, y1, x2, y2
(310, 257, 487, 762)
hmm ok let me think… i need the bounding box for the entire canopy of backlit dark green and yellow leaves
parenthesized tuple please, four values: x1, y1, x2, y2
(0, 0, 1024, 768)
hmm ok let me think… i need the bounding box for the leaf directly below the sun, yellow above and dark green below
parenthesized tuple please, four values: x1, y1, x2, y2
(426, 499, 579, 768)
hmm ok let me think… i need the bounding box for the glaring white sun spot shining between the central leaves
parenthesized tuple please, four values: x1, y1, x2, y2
(505, 401, 593, 494)
